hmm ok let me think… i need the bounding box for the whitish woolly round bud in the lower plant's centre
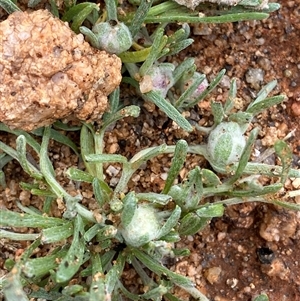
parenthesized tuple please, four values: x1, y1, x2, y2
(121, 205, 160, 247)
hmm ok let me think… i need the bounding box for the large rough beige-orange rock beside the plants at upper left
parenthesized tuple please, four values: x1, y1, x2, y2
(0, 10, 121, 131)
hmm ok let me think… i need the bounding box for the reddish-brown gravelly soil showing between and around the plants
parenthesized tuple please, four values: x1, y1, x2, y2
(0, 0, 300, 301)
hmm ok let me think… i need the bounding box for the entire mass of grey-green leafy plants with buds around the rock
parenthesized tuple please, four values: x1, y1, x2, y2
(0, 0, 300, 301)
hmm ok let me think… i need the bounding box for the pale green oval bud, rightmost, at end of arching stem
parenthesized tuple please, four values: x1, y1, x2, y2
(207, 122, 246, 172)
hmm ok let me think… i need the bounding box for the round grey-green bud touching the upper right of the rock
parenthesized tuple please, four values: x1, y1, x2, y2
(93, 20, 132, 54)
